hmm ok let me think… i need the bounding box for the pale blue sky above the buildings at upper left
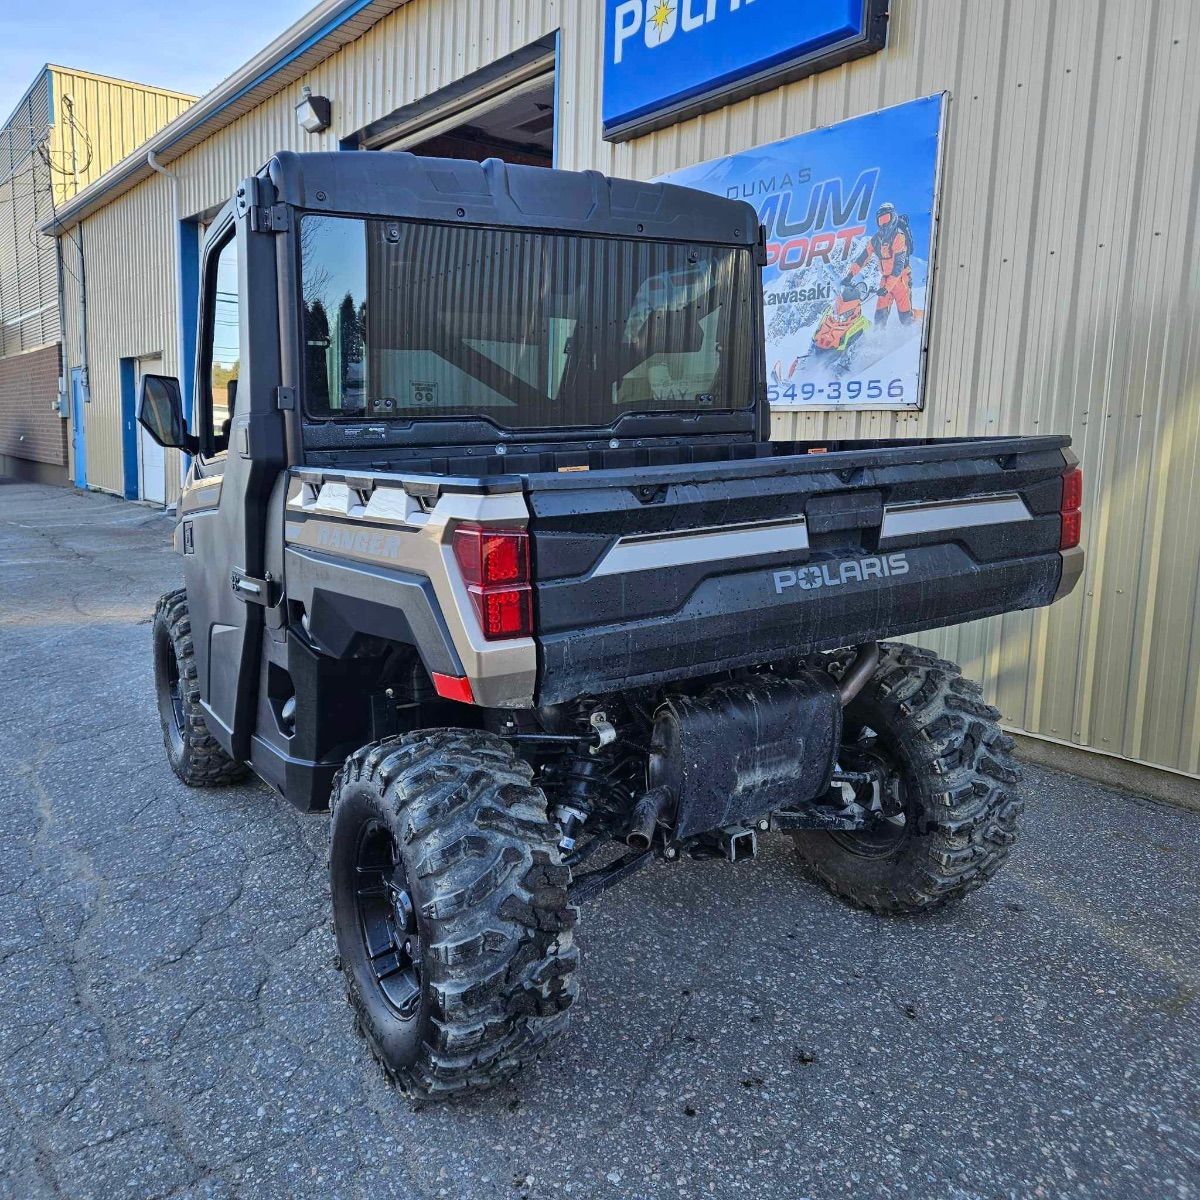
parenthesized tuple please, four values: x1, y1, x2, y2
(0, 0, 317, 121)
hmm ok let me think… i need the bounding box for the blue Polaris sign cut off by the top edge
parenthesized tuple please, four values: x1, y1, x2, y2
(604, 0, 888, 140)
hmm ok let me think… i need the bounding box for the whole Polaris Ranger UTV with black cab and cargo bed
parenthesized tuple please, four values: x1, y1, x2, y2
(139, 152, 1082, 1097)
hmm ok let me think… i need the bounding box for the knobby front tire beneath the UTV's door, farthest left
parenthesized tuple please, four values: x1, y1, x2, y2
(152, 588, 247, 787)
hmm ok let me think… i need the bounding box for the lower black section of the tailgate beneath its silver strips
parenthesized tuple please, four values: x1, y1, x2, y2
(538, 545, 1065, 703)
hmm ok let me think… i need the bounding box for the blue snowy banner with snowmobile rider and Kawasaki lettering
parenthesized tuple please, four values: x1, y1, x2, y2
(662, 95, 943, 409)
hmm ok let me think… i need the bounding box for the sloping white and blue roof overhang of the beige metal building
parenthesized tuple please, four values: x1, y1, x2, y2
(41, 0, 408, 236)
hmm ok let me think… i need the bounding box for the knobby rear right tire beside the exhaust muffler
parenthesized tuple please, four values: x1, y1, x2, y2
(794, 644, 1025, 913)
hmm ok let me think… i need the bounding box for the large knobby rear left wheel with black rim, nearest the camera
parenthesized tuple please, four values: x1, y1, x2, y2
(330, 730, 578, 1098)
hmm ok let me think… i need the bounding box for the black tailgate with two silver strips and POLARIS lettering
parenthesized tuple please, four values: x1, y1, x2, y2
(527, 437, 1074, 703)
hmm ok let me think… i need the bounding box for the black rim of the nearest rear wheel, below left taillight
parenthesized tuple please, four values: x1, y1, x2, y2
(354, 821, 422, 1021)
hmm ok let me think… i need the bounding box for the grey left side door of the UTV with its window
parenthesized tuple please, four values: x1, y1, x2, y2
(181, 206, 286, 761)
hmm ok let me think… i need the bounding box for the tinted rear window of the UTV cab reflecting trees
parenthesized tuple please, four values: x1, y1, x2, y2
(300, 215, 755, 428)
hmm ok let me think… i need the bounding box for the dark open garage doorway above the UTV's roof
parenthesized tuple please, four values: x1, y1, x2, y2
(350, 37, 557, 167)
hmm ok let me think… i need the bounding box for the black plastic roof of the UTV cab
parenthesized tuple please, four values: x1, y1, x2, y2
(259, 150, 758, 246)
